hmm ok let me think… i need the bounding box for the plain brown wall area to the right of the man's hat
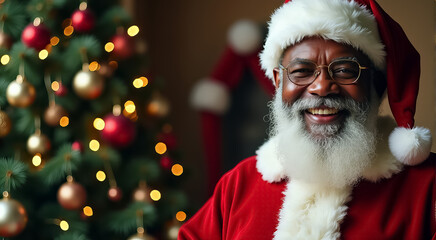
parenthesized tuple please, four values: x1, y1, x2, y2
(378, 0, 436, 152)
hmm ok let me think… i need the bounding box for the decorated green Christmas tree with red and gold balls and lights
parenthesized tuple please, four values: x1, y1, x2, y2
(0, 0, 187, 240)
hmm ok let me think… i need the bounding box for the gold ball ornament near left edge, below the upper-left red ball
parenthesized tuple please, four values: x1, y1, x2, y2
(6, 75, 36, 108)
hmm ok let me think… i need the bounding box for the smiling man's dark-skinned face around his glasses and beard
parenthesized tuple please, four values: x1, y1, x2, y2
(274, 37, 371, 136)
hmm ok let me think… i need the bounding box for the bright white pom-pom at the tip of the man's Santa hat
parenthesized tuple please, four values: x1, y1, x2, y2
(389, 127, 432, 165)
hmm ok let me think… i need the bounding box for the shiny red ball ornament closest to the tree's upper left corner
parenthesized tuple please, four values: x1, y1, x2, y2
(21, 23, 50, 51)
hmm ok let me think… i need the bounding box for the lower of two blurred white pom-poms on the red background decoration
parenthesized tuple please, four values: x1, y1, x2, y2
(191, 79, 230, 114)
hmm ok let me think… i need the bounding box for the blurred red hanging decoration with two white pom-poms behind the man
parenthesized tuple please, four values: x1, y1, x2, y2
(190, 19, 274, 191)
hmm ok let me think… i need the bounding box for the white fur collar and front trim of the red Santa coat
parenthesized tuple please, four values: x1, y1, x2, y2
(256, 117, 403, 240)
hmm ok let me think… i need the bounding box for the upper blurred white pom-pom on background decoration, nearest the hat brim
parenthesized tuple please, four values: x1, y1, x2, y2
(227, 20, 262, 55)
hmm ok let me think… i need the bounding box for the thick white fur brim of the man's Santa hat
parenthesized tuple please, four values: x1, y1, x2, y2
(260, 0, 386, 79)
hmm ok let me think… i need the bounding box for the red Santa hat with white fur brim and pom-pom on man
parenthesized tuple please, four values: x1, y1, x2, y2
(260, 0, 431, 165)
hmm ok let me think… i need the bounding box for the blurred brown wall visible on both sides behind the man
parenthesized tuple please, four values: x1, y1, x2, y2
(133, 0, 436, 203)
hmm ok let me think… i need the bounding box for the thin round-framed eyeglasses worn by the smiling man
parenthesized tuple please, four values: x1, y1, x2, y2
(280, 58, 369, 86)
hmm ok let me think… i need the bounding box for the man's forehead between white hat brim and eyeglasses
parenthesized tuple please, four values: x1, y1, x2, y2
(283, 37, 369, 64)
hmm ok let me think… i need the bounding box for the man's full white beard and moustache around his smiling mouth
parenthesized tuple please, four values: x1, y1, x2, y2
(271, 79, 378, 188)
